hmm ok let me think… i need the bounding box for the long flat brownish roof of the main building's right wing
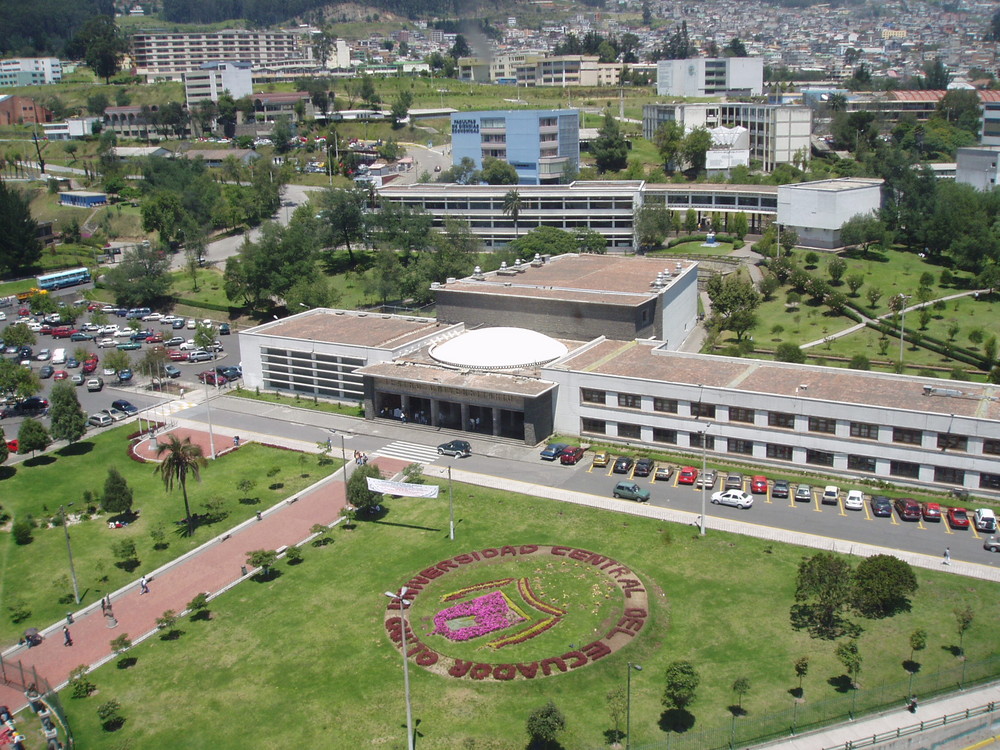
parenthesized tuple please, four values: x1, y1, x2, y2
(556, 341, 1000, 420)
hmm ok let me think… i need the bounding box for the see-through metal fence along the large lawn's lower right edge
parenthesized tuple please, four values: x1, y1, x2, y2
(632, 656, 1000, 750)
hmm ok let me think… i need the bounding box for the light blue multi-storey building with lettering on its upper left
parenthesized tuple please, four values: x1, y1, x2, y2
(451, 109, 580, 185)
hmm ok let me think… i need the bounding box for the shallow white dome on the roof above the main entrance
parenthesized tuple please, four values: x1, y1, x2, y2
(430, 328, 569, 370)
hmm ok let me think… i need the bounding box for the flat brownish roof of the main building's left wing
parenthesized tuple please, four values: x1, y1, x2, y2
(242, 308, 449, 349)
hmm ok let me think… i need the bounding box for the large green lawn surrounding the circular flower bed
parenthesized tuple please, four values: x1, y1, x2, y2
(63, 485, 1000, 750)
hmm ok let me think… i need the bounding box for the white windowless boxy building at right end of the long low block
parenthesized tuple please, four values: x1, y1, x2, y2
(778, 177, 882, 249)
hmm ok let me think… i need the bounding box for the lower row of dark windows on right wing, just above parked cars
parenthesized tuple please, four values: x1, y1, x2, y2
(581, 417, 988, 489)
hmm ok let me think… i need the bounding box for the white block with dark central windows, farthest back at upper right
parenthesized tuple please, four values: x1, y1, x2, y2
(656, 57, 764, 96)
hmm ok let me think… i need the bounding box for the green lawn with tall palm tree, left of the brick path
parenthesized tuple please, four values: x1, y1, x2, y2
(0, 432, 341, 643)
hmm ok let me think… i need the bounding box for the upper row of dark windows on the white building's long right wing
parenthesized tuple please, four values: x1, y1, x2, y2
(580, 388, 1000, 456)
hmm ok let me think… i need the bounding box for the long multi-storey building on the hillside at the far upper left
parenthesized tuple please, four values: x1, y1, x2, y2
(132, 29, 316, 81)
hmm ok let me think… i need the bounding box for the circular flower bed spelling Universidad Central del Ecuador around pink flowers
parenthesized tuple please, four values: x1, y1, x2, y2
(384, 544, 649, 681)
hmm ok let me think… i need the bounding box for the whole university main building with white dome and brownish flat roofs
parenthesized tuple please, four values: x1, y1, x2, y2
(241, 255, 1000, 492)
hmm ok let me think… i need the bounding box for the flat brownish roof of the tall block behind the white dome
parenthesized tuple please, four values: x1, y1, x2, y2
(439, 254, 697, 305)
